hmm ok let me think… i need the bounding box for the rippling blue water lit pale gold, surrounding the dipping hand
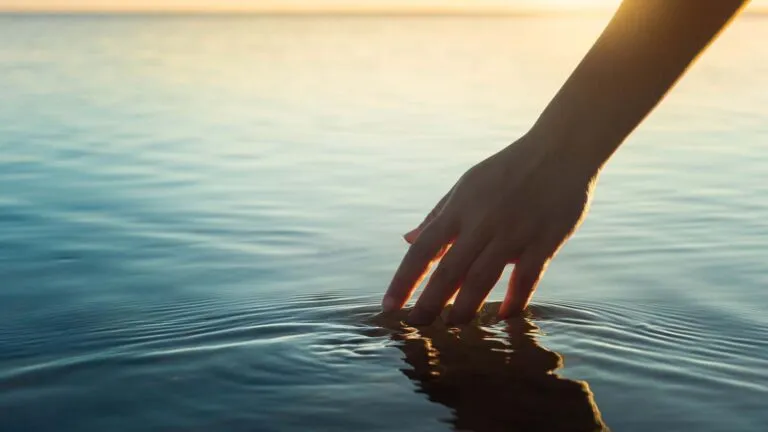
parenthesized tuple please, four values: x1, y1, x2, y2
(0, 15, 768, 432)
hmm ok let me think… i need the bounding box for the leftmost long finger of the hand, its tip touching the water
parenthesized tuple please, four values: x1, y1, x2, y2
(381, 220, 450, 312)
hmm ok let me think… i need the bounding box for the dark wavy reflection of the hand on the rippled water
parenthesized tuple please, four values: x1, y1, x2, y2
(374, 303, 607, 432)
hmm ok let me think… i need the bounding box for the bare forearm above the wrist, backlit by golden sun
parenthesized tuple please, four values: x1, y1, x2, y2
(531, 0, 748, 170)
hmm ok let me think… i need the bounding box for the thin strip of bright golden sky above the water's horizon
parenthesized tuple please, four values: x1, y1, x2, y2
(0, 0, 768, 12)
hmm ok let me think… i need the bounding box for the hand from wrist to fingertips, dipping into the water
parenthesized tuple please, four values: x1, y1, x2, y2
(382, 136, 598, 325)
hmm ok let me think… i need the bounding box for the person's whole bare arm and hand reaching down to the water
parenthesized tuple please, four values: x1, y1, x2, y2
(382, 0, 747, 325)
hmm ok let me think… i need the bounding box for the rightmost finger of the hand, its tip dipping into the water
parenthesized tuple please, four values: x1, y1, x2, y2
(499, 247, 552, 319)
